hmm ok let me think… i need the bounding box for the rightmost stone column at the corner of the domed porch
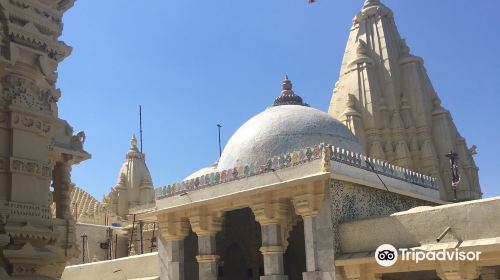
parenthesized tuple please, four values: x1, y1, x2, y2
(292, 186, 324, 280)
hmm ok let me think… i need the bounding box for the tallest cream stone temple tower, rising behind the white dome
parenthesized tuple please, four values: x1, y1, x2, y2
(329, 0, 481, 200)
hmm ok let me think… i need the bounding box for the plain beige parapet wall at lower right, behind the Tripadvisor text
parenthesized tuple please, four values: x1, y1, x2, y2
(340, 197, 500, 253)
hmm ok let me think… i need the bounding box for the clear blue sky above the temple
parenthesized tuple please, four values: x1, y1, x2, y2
(58, 0, 500, 199)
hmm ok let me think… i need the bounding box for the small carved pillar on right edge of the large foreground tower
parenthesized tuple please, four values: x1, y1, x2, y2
(52, 154, 73, 219)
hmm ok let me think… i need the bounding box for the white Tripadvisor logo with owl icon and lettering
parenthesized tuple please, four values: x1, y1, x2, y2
(375, 244, 482, 267)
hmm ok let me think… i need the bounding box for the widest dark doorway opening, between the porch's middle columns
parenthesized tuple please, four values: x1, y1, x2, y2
(217, 208, 264, 280)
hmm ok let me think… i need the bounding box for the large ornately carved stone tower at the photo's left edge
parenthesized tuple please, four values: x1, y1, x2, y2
(0, 0, 90, 279)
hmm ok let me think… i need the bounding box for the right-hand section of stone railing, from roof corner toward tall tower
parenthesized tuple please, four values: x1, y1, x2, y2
(329, 146, 439, 190)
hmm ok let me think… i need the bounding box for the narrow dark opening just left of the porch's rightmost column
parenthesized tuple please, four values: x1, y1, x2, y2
(283, 217, 306, 280)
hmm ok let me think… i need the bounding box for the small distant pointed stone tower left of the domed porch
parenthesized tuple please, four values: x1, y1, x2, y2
(107, 135, 154, 218)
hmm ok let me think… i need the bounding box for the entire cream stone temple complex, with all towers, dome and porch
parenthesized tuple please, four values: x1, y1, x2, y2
(0, 0, 500, 280)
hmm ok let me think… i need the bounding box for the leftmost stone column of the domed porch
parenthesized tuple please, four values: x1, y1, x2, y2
(158, 214, 189, 280)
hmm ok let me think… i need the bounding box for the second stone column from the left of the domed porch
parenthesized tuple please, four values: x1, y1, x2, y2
(189, 209, 221, 280)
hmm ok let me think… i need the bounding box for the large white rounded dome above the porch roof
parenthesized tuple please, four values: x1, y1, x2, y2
(218, 104, 364, 170)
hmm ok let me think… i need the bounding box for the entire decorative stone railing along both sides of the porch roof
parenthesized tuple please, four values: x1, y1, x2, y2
(155, 144, 438, 200)
